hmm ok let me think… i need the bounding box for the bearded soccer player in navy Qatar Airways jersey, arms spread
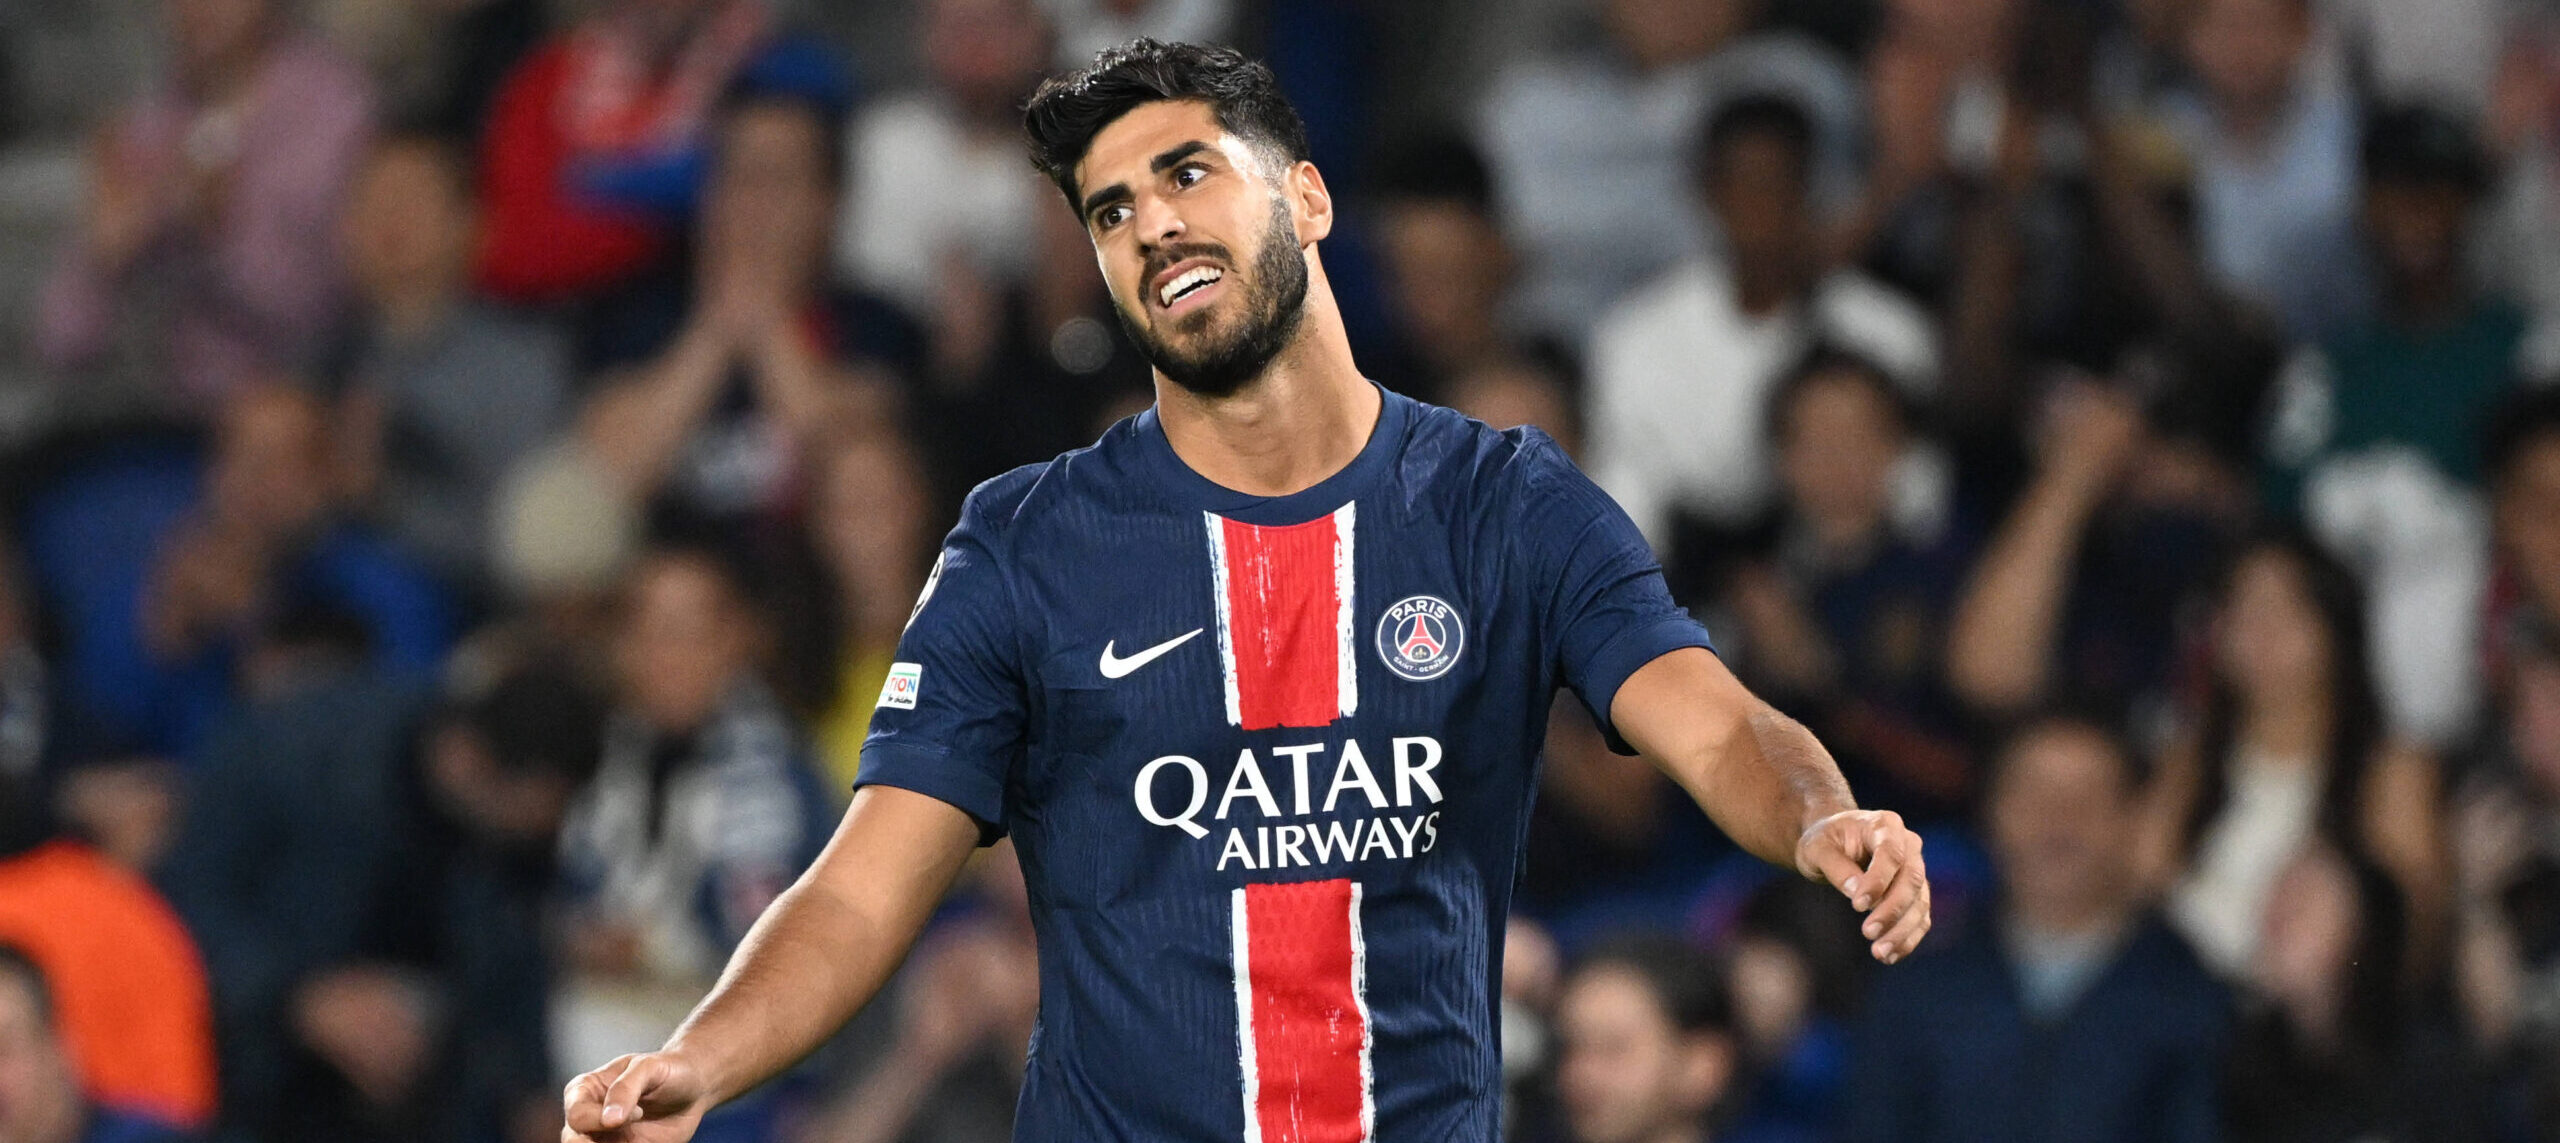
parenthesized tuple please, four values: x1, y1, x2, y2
(566, 41, 1928, 1143)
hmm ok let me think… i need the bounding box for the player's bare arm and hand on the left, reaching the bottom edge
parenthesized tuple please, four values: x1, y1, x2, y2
(561, 787, 978, 1143)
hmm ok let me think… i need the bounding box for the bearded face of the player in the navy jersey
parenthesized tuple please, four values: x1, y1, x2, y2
(1075, 100, 1329, 397)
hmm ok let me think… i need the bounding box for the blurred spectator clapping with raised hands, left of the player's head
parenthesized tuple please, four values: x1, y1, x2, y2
(581, 92, 922, 548)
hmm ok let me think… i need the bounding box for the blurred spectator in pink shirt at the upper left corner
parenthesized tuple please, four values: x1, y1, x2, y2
(36, 0, 374, 410)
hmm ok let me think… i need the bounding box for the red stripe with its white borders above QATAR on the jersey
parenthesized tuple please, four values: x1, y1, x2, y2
(1203, 505, 1359, 730)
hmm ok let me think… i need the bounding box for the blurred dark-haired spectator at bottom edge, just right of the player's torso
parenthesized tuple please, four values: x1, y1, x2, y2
(1556, 935, 1748, 1143)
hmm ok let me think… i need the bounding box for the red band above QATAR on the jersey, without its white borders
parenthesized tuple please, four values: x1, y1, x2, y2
(1219, 515, 1341, 730)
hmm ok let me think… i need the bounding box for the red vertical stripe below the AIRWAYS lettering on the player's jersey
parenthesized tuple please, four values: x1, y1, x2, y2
(1242, 879, 1372, 1143)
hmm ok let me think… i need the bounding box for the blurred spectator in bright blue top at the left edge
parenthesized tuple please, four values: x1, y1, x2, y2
(26, 384, 453, 761)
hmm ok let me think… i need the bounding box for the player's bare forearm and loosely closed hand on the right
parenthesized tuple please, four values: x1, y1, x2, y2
(1608, 646, 1930, 964)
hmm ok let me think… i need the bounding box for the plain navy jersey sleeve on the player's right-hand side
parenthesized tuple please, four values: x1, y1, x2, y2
(1510, 431, 1715, 753)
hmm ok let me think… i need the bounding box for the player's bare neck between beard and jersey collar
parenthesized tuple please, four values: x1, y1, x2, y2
(1155, 270, 1380, 497)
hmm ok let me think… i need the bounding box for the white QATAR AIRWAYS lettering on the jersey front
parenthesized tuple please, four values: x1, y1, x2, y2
(1129, 736, 1441, 871)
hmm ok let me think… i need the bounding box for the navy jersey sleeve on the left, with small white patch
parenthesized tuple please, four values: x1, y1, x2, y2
(855, 497, 1027, 841)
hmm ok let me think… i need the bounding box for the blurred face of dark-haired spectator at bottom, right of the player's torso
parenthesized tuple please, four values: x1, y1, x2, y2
(1556, 969, 1728, 1143)
